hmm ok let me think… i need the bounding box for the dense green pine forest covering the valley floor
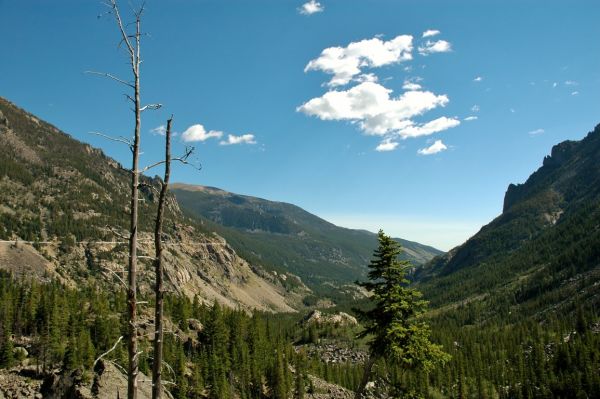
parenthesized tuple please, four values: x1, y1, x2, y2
(0, 272, 600, 398)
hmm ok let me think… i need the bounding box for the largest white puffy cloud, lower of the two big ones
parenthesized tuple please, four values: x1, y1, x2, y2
(297, 82, 460, 138)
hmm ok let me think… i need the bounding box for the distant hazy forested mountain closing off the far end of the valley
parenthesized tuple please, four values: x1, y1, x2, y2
(173, 184, 442, 292)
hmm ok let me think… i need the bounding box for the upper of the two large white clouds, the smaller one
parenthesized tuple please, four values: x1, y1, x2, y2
(304, 35, 413, 87)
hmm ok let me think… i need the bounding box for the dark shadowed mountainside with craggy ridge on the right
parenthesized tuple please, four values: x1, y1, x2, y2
(416, 125, 600, 315)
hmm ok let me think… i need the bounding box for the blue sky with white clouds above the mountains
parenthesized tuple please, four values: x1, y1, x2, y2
(0, 0, 600, 249)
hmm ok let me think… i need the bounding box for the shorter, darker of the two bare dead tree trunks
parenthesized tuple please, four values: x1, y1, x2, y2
(152, 117, 173, 399)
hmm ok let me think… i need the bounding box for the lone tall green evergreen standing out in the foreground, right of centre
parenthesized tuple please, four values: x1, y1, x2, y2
(356, 230, 450, 399)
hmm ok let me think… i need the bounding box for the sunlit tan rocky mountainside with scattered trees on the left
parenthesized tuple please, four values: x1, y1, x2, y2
(0, 98, 308, 312)
